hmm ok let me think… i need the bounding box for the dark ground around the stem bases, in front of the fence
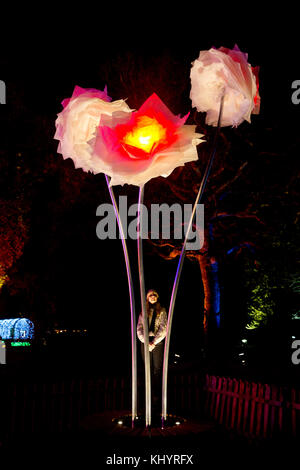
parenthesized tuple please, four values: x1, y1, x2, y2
(1, 412, 297, 469)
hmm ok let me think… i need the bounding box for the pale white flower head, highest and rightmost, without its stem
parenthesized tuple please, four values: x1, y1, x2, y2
(190, 45, 260, 127)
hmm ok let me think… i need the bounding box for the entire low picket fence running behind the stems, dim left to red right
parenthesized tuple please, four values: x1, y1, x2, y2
(0, 373, 300, 441)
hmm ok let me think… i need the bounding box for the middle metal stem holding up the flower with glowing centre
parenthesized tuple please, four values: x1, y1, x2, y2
(137, 186, 151, 427)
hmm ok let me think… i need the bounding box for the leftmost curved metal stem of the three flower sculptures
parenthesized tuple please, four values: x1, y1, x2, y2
(105, 175, 137, 427)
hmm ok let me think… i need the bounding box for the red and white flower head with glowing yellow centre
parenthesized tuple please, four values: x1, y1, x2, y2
(93, 93, 202, 186)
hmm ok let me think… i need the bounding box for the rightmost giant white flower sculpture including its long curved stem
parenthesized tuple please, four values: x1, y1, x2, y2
(162, 46, 260, 419)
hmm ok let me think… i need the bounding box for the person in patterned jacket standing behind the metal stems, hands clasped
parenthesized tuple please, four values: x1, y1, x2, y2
(137, 289, 168, 412)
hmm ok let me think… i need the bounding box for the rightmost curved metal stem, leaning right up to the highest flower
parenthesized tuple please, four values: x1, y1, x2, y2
(162, 94, 225, 426)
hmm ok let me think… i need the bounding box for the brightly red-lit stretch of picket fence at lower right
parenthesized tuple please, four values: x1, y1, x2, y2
(204, 375, 300, 438)
